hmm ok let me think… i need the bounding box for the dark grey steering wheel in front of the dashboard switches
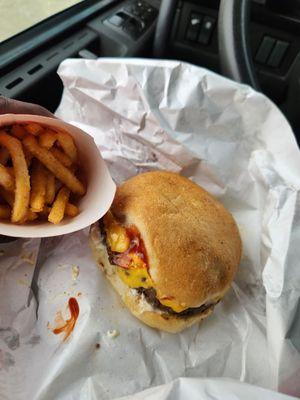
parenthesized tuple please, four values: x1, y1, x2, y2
(153, 0, 260, 91)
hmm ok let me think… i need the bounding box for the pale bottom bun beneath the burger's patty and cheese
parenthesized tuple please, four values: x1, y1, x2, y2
(89, 223, 213, 333)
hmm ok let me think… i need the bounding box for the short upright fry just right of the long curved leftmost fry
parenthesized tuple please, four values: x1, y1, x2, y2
(30, 160, 47, 212)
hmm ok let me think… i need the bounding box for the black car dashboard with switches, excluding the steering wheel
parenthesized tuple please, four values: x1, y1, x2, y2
(0, 0, 300, 142)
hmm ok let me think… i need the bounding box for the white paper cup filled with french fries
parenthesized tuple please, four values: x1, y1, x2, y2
(0, 114, 116, 237)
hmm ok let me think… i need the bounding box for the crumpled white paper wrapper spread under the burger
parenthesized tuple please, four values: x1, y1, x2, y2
(0, 59, 300, 400)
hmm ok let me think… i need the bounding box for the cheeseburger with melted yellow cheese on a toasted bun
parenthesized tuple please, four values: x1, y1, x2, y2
(90, 171, 241, 333)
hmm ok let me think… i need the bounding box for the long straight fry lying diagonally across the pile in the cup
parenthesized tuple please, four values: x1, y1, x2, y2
(23, 136, 85, 195)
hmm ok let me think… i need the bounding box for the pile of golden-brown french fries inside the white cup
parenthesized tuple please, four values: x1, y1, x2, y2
(0, 123, 86, 224)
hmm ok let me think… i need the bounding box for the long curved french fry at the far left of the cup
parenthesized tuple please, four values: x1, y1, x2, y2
(0, 131, 30, 222)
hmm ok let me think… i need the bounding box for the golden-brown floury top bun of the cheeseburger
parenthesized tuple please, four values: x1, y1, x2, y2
(111, 171, 241, 307)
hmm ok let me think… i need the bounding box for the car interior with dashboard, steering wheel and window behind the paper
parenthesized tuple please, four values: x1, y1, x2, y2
(0, 0, 300, 143)
